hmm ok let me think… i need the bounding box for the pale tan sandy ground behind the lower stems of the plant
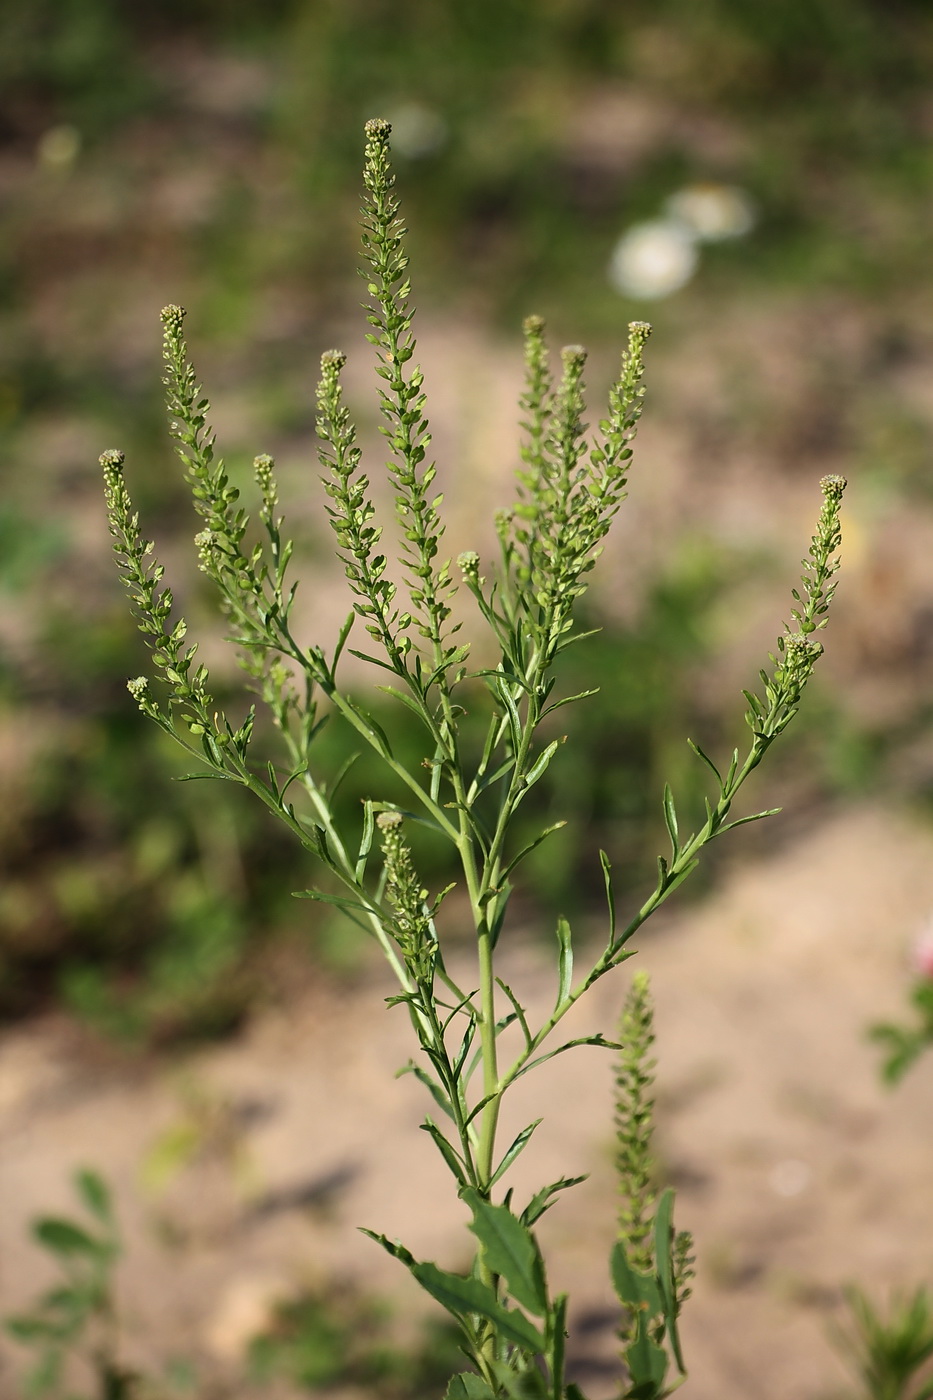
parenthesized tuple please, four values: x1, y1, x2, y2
(0, 805, 933, 1400)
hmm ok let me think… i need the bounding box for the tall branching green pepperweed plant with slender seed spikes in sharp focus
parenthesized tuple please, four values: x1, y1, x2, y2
(101, 120, 845, 1400)
